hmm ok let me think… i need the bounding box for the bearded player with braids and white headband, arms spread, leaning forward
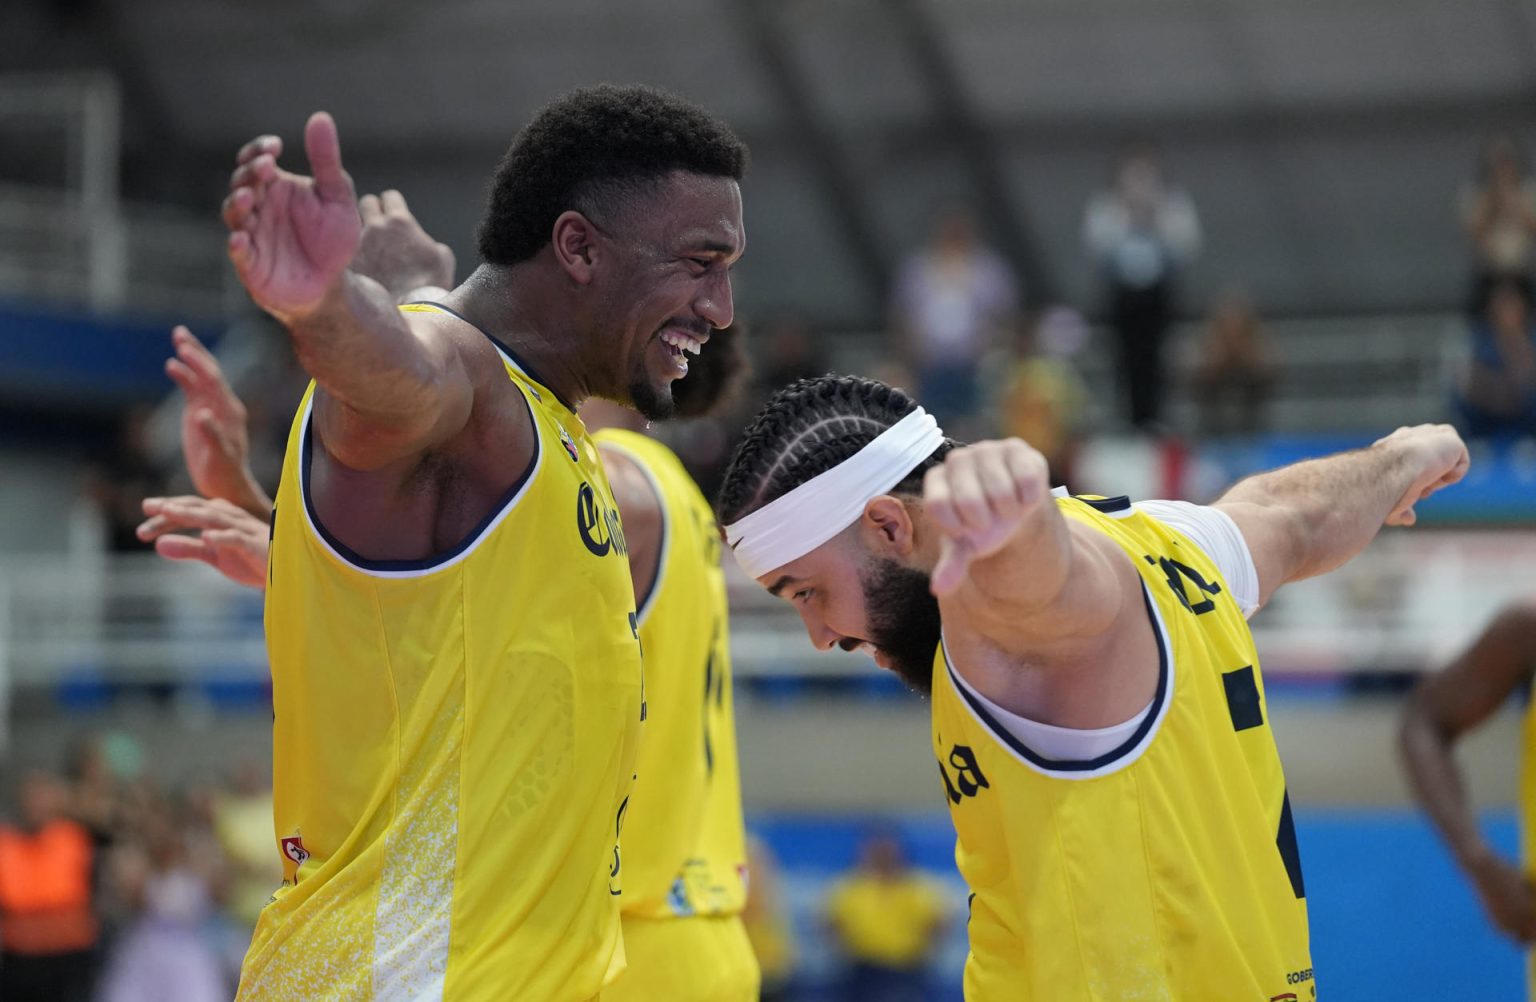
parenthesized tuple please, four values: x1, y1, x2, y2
(719, 377, 1467, 1002)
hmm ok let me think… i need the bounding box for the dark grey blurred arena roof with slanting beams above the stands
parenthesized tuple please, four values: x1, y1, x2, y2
(18, 0, 1536, 326)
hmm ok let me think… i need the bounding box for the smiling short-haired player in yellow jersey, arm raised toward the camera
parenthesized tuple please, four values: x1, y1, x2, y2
(215, 88, 745, 999)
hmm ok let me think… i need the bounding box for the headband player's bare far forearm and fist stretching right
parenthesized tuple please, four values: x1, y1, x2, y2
(1213, 424, 1468, 604)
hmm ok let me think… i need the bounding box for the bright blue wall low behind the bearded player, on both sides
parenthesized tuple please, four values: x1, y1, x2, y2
(751, 810, 1524, 1002)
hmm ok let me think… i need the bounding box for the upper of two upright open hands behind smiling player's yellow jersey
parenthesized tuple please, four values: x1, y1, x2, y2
(166, 326, 272, 518)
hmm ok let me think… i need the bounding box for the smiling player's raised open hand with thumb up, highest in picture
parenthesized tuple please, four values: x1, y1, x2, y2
(223, 111, 362, 323)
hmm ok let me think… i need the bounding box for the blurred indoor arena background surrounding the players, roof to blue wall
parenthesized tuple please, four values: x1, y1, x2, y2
(0, 0, 1536, 1000)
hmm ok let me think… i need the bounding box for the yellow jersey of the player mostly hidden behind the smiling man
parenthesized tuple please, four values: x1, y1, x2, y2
(594, 429, 746, 919)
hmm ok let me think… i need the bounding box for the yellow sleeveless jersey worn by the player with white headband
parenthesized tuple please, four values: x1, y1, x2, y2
(932, 498, 1316, 1002)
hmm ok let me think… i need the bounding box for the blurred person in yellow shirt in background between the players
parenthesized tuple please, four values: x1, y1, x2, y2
(826, 833, 945, 1002)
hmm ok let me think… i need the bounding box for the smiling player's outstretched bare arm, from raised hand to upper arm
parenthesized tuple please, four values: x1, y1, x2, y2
(224, 112, 473, 470)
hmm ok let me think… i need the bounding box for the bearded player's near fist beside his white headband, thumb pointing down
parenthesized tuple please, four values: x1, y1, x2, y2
(923, 438, 1051, 596)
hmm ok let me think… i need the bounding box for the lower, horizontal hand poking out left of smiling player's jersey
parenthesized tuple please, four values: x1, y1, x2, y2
(138, 495, 267, 589)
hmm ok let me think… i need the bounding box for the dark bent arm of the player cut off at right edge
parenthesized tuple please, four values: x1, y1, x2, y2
(1398, 601, 1536, 944)
